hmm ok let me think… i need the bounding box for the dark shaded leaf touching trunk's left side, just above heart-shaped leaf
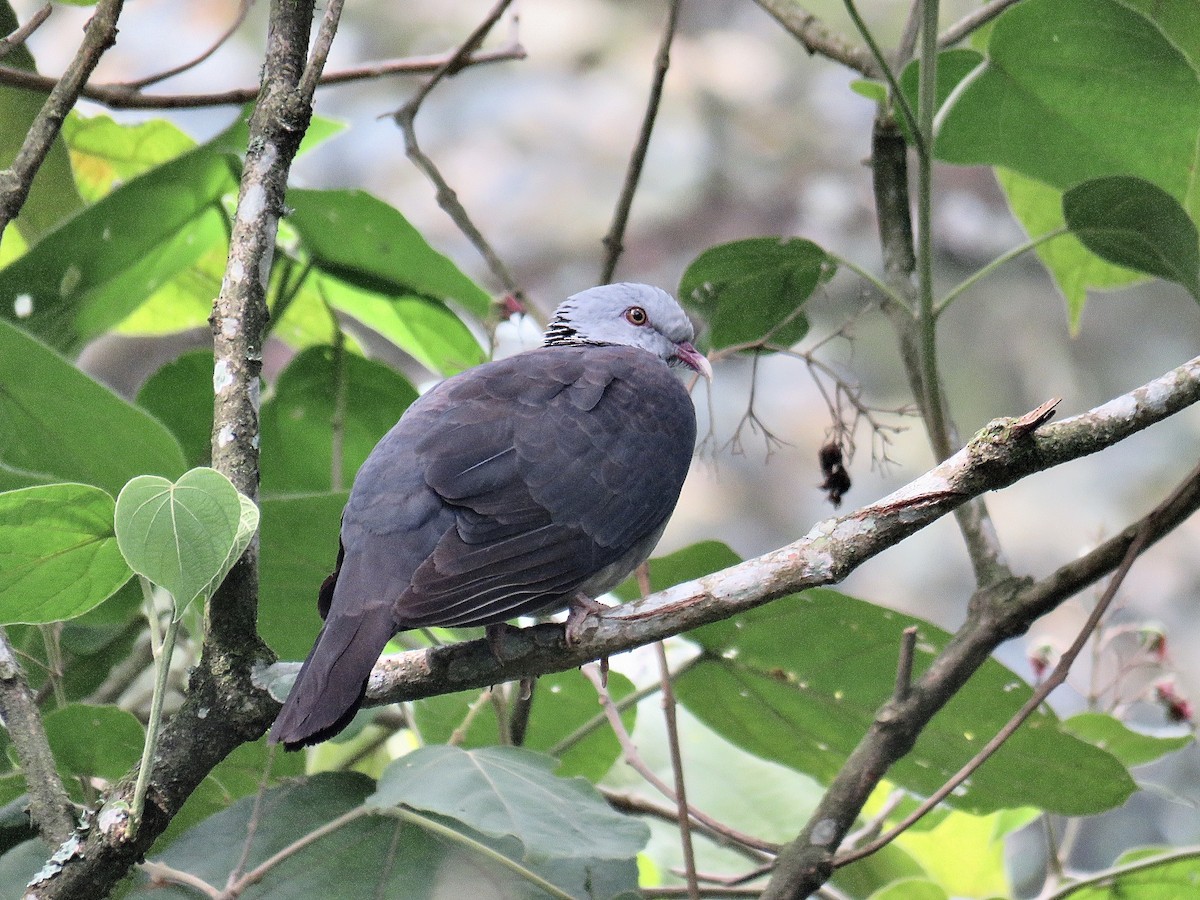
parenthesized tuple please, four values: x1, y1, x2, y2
(138, 350, 212, 467)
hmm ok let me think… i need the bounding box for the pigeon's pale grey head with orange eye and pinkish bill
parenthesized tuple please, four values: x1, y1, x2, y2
(545, 282, 713, 379)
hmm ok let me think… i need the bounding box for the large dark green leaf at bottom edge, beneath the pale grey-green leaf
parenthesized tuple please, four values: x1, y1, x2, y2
(131, 774, 637, 900)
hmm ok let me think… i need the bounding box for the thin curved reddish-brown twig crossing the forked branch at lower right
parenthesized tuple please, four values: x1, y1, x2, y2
(834, 466, 1200, 866)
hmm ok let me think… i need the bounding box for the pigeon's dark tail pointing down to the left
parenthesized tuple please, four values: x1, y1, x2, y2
(268, 605, 395, 750)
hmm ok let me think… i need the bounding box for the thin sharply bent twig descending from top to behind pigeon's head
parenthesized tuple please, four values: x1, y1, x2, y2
(392, 0, 524, 306)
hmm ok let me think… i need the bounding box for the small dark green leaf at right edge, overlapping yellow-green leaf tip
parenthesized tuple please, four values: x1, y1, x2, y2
(1062, 175, 1200, 300)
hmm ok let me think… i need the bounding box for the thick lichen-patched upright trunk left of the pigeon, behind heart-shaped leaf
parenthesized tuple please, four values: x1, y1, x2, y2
(26, 0, 323, 898)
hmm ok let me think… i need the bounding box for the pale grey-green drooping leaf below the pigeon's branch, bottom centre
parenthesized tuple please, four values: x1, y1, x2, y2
(366, 745, 649, 859)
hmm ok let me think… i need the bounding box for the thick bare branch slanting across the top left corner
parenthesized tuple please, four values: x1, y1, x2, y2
(0, 0, 124, 238)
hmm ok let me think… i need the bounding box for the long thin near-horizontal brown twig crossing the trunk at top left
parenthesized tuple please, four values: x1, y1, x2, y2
(0, 44, 526, 109)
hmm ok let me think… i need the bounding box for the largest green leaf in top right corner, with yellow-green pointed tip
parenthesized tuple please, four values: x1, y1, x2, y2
(935, 0, 1200, 316)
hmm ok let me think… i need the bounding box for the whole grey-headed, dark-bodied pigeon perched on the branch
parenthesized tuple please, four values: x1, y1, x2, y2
(269, 283, 713, 750)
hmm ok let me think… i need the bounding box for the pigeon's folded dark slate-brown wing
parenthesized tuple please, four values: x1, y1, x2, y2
(395, 347, 696, 628)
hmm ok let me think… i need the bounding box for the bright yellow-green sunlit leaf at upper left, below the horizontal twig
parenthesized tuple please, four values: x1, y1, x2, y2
(62, 112, 196, 203)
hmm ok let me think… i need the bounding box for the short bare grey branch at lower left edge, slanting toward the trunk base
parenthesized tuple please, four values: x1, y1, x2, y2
(0, 629, 76, 846)
